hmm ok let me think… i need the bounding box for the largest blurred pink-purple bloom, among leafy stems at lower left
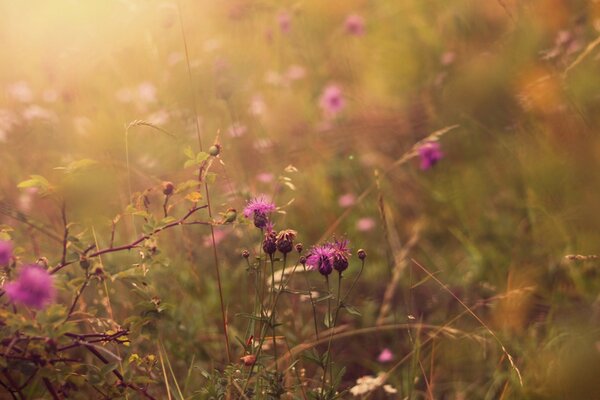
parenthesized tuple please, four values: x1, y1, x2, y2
(4, 265, 55, 308)
